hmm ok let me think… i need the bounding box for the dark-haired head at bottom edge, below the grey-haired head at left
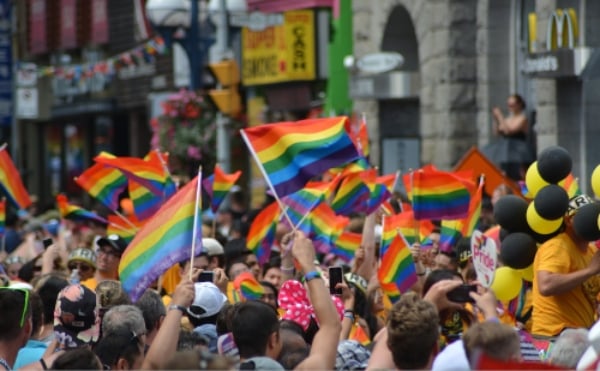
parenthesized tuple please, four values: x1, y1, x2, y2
(94, 329, 141, 368)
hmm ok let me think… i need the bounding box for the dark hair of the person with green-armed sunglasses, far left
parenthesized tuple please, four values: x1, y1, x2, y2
(0, 288, 31, 341)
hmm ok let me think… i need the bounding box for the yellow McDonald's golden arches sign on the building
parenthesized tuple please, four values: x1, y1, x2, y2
(529, 8, 579, 53)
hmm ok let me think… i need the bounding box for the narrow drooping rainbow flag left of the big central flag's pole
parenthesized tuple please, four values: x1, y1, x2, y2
(246, 202, 281, 264)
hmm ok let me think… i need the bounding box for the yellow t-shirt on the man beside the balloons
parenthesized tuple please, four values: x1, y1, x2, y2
(531, 233, 600, 336)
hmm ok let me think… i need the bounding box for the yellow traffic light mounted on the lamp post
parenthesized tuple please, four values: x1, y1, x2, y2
(208, 59, 242, 116)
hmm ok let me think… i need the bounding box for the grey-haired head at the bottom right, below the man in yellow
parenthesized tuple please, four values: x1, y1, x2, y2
(549, 328, 590, 370)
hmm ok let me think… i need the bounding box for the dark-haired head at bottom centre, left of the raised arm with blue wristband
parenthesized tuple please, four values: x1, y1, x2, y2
(231, 300, 281, 359)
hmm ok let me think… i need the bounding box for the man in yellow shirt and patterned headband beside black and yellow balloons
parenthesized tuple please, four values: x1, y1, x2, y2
(531, 195, 600, 337)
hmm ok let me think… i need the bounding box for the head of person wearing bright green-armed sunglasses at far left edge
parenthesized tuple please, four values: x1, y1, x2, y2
(0, 287, 33, 347)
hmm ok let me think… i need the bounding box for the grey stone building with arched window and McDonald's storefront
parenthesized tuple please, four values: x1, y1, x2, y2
(351, 0, 600, 189)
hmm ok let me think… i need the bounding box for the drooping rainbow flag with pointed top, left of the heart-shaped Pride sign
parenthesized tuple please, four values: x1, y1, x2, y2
(377, 235, 418, 293)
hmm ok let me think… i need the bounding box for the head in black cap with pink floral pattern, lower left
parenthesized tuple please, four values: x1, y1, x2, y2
(54, 284, 99, 349)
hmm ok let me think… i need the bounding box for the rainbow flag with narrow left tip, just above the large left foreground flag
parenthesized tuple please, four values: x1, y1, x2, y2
(94, 152, 172, 197)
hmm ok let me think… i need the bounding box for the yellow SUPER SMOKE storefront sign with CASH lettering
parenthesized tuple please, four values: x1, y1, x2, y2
(242, 10, 316, 86)
